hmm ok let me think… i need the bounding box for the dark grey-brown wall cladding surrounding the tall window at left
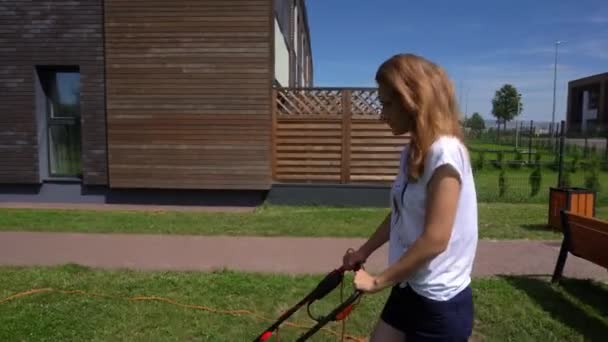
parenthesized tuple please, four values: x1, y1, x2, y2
(0, 0, 107, 184)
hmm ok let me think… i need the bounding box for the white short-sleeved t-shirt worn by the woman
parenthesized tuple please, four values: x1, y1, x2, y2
(389, 136, 477, 301)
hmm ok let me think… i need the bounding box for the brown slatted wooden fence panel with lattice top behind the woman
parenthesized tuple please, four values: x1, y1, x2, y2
(273, 88, 407, 184)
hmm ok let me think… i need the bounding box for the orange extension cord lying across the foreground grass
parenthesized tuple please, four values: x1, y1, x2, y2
(0, 288, 366, 342)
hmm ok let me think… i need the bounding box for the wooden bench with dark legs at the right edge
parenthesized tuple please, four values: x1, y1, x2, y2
(551, 210, 608, 283)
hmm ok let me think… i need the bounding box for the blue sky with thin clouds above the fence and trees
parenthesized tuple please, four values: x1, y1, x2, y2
(306, 0, 608, 122)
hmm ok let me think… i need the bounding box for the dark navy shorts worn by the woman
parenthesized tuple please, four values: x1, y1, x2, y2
(381, 286, 473, 342)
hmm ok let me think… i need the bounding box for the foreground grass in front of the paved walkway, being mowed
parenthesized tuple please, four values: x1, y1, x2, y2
(0, 265, 608, 341)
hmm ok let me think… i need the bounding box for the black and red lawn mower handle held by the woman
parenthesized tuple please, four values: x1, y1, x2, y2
(253, 265, 362, 342)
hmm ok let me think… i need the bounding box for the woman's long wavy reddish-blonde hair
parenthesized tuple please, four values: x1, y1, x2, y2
(376, 54, 463, 181)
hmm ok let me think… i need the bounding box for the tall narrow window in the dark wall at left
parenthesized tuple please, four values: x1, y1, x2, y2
(38, 67, 82, 177)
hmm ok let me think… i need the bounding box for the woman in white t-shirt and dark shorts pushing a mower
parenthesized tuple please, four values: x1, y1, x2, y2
(343, 54, 477, 341)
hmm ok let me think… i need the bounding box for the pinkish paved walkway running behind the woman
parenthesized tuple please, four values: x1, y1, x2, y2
(0, 232, 608, 280)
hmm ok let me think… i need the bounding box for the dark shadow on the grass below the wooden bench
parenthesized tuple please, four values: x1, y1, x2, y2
(503, 276, 608, 341)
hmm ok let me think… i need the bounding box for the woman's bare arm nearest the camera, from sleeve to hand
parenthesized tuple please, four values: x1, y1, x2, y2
(355, 165, 461, 292)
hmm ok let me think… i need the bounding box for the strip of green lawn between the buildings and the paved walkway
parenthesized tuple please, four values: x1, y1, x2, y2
(0, 203, 608, 239)
